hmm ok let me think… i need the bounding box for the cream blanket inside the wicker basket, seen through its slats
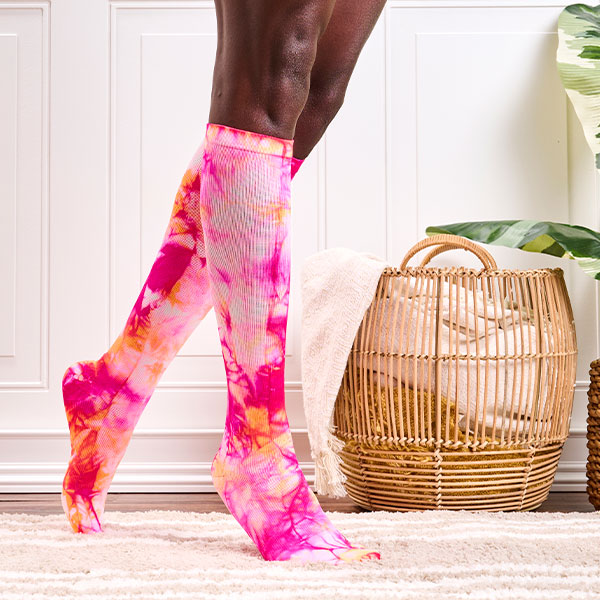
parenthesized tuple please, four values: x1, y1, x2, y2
(376, 278, 552, 436)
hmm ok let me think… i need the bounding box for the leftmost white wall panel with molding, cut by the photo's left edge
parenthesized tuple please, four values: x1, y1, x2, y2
(0, 2, 50, 393)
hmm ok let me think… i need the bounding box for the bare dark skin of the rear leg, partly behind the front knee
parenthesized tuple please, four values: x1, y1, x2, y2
(294, 0, 386, 159)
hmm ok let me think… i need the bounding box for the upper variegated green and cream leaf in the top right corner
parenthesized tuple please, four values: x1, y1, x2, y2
(556, 4, 600, 169)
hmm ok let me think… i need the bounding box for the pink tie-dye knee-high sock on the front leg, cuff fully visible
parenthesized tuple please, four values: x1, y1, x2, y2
(200, 123, 379, 562)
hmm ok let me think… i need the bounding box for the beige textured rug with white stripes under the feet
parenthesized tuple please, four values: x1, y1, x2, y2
(0, 511, 600, 600)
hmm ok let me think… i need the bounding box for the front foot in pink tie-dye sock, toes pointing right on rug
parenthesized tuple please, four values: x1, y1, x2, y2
(211, 430, 381, 564)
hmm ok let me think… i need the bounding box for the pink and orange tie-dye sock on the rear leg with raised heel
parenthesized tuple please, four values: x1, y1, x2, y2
(61, 142, 212, 533)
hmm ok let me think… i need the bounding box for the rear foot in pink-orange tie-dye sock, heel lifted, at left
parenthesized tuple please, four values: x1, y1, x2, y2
(61, 359, 144, 533)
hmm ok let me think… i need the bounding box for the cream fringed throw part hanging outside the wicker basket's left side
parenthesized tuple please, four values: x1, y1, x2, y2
(301, 248, 391, 498)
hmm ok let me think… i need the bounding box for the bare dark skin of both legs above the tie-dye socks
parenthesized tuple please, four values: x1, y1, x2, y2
(209, 0, 385, 150)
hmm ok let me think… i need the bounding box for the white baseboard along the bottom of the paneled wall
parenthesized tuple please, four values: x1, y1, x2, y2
(0, 429, 587, 494)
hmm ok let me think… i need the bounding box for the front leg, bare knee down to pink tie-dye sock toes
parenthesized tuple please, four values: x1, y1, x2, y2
(200, 0, 379, 562)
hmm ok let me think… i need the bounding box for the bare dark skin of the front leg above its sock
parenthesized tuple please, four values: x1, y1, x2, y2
(209, 0, 335, 139)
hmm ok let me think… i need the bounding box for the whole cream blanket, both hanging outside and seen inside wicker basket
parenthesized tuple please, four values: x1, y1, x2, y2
(301, 248, 548, 497)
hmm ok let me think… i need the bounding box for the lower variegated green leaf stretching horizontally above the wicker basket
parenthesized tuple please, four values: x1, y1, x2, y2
(425, 221, 600, 279)
